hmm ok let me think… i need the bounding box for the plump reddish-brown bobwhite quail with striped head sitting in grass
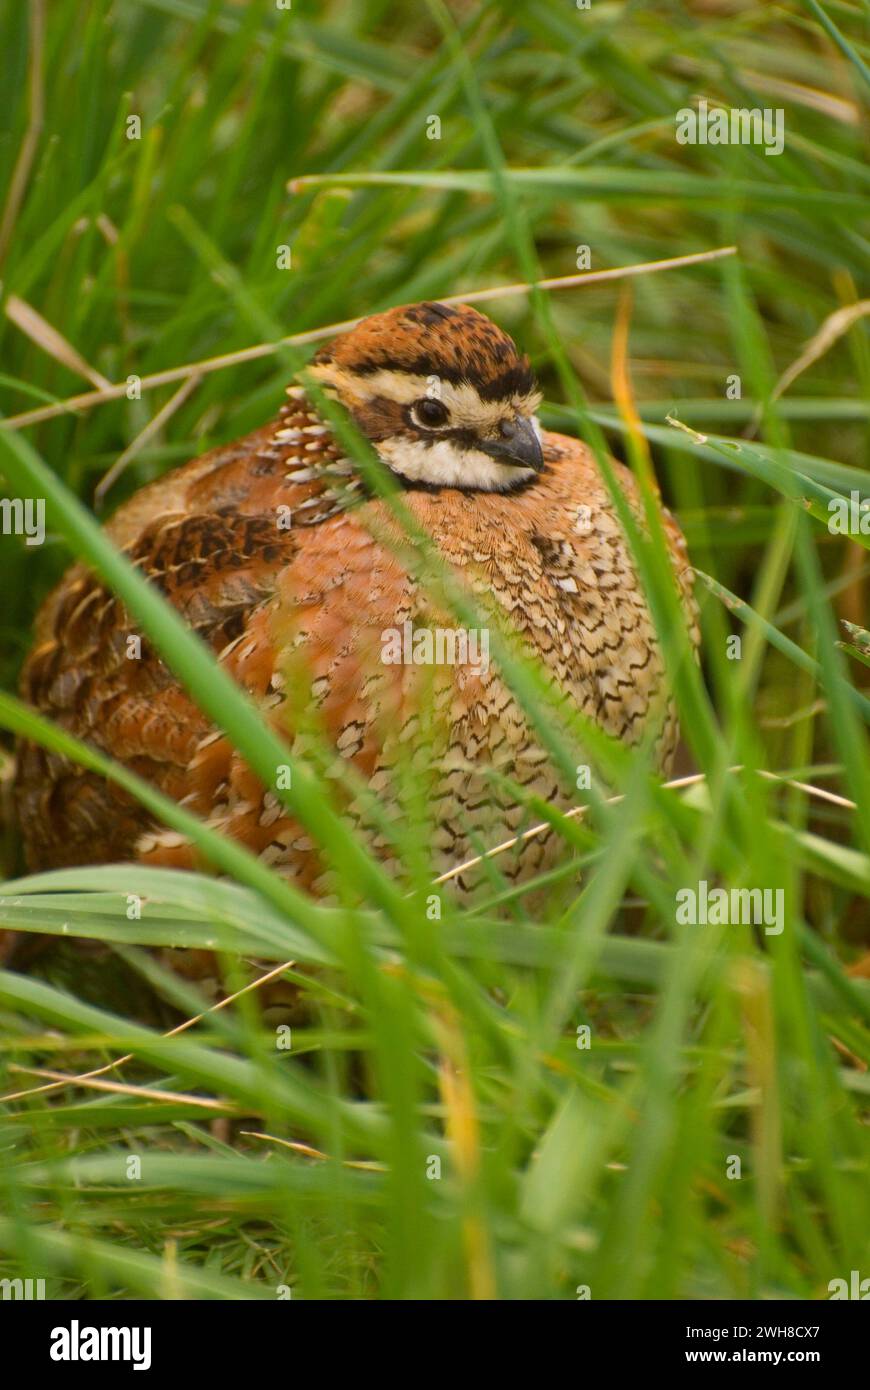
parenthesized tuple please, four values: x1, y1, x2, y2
(17, 303, 696, 892)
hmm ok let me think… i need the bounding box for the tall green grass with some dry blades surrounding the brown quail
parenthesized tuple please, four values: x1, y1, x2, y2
(0, 0, 870, 1298)
